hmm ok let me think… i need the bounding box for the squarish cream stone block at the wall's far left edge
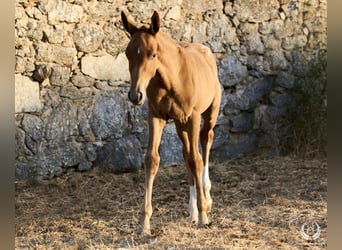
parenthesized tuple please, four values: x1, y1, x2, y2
(15, 74, 43, 113)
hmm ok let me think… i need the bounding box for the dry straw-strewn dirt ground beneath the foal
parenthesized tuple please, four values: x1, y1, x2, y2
(15, 157, 327, 249)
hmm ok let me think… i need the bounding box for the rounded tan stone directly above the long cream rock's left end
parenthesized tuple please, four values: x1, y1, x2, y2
(74, 23, 104, 53)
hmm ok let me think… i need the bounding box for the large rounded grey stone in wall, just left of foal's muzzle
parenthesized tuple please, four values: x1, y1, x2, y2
(90, 91, 127, 140)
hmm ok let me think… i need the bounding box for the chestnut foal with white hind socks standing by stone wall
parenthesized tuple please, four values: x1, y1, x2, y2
(121, 11, 221, 234)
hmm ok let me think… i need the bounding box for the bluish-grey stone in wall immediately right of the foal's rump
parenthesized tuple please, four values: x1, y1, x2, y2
(219, 56, 248, 87)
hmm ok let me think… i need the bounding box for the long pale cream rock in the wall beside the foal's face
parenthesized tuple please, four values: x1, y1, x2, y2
(81, 53, 130, 81)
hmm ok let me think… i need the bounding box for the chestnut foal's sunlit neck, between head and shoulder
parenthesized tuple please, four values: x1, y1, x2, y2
(158, 32, 182, 89)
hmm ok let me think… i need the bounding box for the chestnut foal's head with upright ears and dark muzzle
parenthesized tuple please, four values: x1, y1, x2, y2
(121, 11, 160, 105)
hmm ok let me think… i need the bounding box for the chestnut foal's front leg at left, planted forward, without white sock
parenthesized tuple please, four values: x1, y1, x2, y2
(141, 114, 166, 235)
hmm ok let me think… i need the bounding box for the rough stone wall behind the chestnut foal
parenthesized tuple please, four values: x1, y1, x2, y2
(15, 0, 327, 180)
